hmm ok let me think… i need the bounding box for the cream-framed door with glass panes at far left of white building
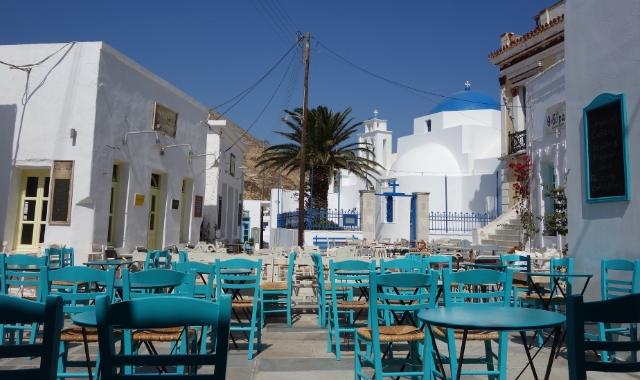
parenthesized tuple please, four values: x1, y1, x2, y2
(14, 170, 51, 251)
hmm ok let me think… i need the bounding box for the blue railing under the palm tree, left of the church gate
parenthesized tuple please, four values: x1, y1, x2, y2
(278, 209, 360, 231)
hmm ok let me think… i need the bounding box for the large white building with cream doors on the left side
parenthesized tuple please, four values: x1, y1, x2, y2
(0, 42, 242, 262)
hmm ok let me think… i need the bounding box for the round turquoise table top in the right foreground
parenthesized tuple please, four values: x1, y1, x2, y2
(418, 305, 566, 331)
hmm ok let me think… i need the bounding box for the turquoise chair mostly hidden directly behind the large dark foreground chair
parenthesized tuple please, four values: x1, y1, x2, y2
(122, 268, 197, 374)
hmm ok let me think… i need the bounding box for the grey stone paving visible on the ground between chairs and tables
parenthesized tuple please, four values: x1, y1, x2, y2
(0, 302, 640, 380)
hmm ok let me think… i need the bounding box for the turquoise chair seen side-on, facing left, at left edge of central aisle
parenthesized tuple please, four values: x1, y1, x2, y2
(260, 252, 296, 327)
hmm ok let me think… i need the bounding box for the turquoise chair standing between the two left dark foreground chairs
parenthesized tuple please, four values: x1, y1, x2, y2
(40, 266, 117, 379)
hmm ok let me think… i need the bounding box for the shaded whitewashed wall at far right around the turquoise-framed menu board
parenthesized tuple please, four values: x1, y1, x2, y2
(565, 0, 640, 299)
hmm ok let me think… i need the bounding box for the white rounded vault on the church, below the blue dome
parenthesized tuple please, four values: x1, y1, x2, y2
(389, 144, 460, 177)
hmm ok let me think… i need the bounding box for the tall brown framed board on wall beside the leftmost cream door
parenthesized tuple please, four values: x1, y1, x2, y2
(49, 161, 73, 225)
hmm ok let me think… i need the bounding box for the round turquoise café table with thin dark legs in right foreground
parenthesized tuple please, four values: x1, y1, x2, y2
(418, 305, 566, 380)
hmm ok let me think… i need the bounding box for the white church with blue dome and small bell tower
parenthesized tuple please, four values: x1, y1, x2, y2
(271, 82, 502, 240)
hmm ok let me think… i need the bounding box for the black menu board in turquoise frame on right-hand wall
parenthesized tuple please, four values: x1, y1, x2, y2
(583, 93, 631, 203)
